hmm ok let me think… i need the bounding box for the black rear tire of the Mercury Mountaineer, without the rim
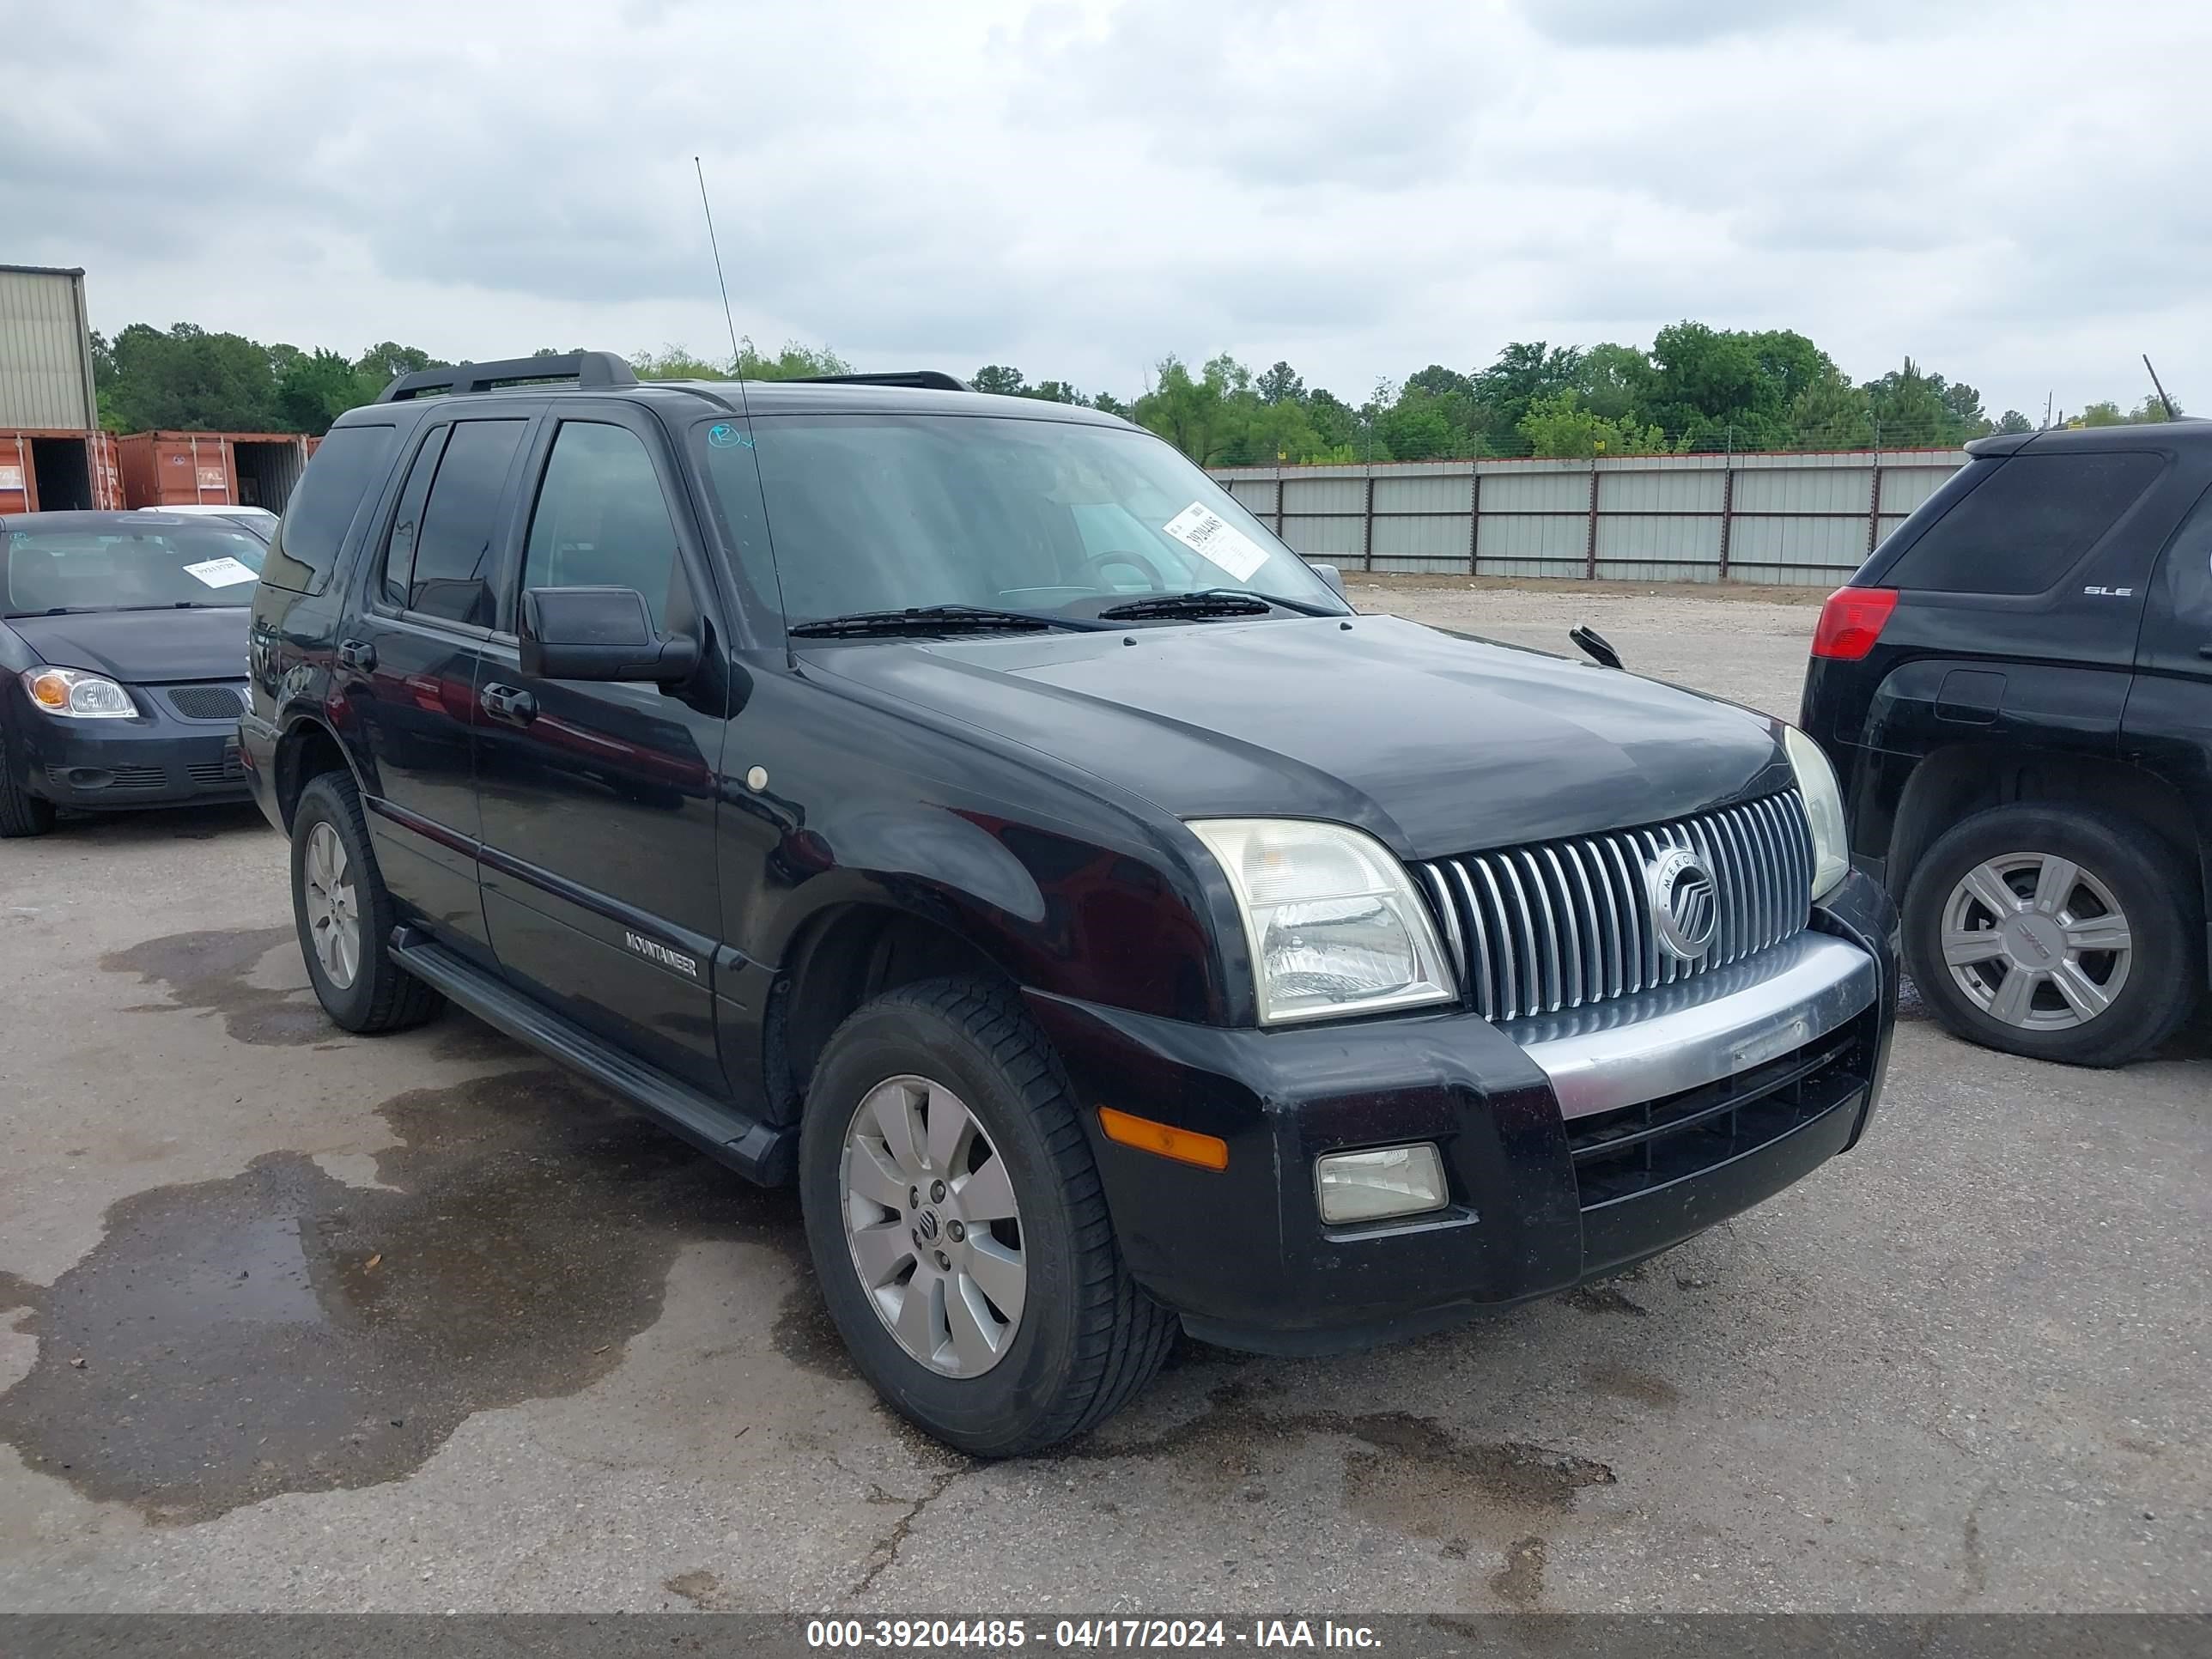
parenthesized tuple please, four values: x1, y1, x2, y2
(292, 772, 445, 1036)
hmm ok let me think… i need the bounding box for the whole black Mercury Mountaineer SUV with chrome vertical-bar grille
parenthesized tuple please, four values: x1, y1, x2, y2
(241, 354, 1896, 1455)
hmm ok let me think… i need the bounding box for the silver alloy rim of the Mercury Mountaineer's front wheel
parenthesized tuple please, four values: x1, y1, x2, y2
(838, 1078, 1029, 1376)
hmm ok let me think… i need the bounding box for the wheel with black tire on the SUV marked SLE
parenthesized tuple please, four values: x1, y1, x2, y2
(1905, 803, 2205, 1066)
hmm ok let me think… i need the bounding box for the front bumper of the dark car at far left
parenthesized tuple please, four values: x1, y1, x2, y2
(7, 688, 248, 811)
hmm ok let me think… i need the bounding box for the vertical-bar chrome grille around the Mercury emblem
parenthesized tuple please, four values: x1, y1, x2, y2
(1416, 790, 1812, 1020)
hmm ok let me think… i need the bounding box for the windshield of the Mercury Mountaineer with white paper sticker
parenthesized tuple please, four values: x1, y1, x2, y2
(695, 414, 1345, 626)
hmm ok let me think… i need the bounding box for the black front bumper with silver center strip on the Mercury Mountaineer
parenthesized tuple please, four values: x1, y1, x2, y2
(1030, 876, 1898, 1354)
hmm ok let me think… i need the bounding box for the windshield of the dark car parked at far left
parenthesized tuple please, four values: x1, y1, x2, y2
(0, 522, 268, 617)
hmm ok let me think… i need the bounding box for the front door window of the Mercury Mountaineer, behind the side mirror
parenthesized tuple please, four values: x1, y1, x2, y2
(522, 420, 677, 629)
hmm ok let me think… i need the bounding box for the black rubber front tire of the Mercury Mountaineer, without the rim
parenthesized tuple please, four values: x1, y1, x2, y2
(799, 980, 1179, 1458)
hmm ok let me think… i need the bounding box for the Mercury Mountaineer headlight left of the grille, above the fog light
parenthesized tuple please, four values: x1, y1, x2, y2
(1190, 818, 1455, 1024)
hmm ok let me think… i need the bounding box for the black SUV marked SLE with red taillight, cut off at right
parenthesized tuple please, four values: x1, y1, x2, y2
(1805, 420, 2212, 1066)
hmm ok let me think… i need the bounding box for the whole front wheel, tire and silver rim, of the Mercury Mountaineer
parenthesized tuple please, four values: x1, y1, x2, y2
(799, 980, 1175, 1458)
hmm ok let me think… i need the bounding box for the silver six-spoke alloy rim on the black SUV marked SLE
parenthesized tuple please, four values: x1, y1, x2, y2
(1942, 852, 2135, 1030)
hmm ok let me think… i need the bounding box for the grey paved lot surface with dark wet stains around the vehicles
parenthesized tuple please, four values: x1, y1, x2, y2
(0, 581, 2212, 1614)
